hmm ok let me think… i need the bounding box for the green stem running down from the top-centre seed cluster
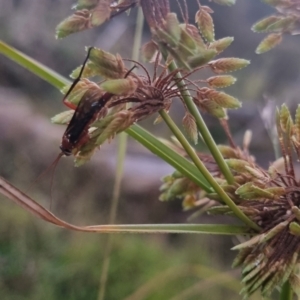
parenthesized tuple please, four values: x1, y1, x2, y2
(169, 60, 234, 184)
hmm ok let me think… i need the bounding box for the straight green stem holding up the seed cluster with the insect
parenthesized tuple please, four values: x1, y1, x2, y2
(160, 110, 260, 230)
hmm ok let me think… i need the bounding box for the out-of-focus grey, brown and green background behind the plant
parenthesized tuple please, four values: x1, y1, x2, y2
(0, 0, 299, 300)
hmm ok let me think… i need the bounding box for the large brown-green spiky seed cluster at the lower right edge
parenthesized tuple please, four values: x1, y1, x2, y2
(160, 105, 300, 298)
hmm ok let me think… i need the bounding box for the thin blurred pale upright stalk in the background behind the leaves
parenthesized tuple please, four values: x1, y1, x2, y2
(98, 9, 144, 300)
